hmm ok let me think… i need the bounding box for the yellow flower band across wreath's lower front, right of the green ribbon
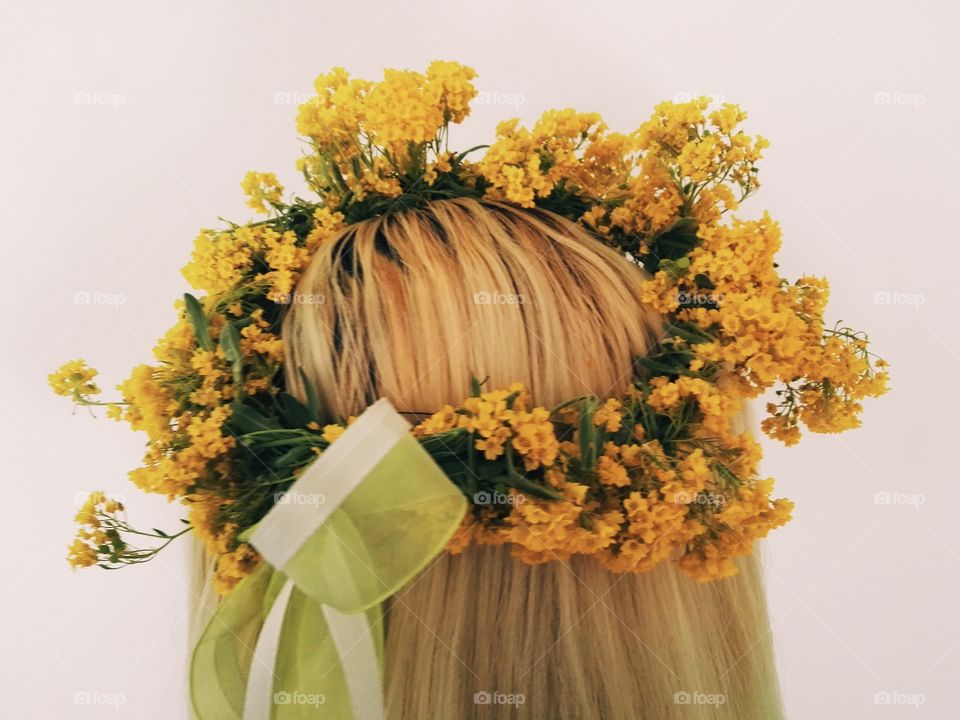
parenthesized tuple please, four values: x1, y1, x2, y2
(414, 386, 792, 581)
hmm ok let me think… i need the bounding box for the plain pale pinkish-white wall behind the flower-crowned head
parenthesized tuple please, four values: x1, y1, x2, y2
(0, 0, 960, 720)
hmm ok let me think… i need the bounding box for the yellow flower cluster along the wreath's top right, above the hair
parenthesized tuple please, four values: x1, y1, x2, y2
(478, 93, 767, 242)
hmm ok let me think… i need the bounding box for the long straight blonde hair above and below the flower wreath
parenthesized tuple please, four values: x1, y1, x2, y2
(283, 199, 782, 720)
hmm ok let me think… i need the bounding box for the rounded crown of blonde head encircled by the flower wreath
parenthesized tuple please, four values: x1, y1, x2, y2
(283, 199, 656, 416)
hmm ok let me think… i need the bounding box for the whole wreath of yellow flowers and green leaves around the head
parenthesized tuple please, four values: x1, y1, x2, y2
(50, 61, 887, 594)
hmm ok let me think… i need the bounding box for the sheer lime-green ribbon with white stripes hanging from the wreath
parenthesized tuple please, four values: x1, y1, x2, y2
(190, 400, 467, 720)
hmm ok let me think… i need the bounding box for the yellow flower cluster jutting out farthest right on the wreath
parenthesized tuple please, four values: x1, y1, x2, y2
(644, 215, 888, 445)
